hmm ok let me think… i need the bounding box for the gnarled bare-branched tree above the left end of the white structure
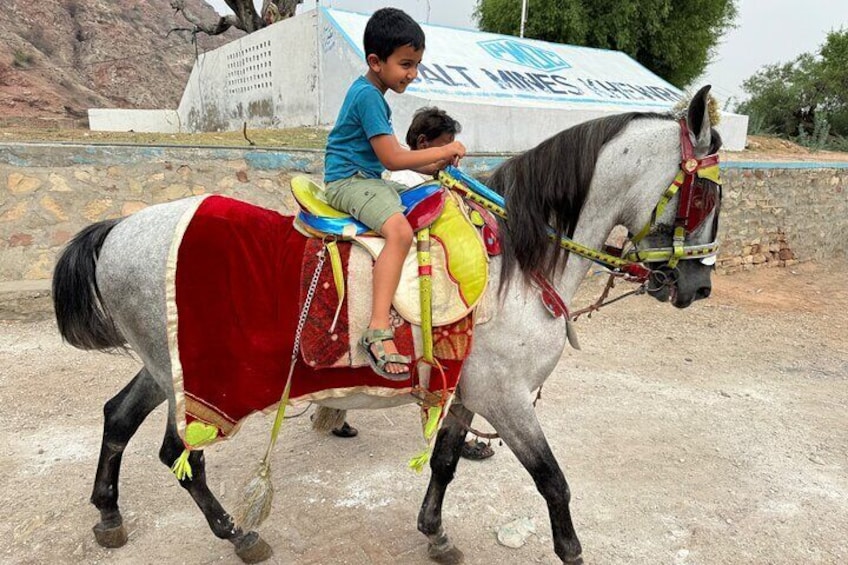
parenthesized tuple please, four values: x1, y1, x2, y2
(171, 0, 303, 35)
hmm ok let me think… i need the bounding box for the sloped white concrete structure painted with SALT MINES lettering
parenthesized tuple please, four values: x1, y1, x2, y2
(92, 8, 748, 153)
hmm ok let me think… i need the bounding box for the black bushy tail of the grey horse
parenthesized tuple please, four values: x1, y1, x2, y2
(53, 219, 126, 349)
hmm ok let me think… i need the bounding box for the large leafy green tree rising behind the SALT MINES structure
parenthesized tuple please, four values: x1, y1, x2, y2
(475, 0, 736, 88)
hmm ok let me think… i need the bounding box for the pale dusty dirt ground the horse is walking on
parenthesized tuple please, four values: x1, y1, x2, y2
(0, 262, 848, 565)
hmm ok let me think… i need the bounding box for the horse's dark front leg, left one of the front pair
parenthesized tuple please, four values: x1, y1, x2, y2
(418, 403, 474, 564)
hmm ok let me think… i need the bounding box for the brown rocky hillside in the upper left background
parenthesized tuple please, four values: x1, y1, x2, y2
(0, 0, 241, 125)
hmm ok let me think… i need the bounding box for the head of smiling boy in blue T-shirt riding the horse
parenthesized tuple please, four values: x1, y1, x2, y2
(363, 8, 424, 94)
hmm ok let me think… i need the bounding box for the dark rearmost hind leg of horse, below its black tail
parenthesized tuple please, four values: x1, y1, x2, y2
(91, 369, 165, 547)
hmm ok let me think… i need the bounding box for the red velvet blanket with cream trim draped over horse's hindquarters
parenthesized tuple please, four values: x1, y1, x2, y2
(167, 196, 462, 439)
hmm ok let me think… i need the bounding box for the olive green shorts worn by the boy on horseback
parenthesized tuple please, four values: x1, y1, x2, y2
(324, 175, 407, 232)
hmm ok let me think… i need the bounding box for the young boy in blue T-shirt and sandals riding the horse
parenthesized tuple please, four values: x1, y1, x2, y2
(324, 8, 465, 380)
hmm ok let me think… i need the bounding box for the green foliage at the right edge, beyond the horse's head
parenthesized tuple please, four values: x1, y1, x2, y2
(736, 30, 848, 145)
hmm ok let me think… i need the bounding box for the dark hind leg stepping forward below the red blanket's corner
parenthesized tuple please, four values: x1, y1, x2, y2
(159, 412, 273, 563)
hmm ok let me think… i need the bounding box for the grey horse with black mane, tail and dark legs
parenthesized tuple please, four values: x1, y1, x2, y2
(53, 87, 720, 563)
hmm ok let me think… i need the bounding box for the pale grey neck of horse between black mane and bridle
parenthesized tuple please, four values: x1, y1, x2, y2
(552, 120, 679, 306)
